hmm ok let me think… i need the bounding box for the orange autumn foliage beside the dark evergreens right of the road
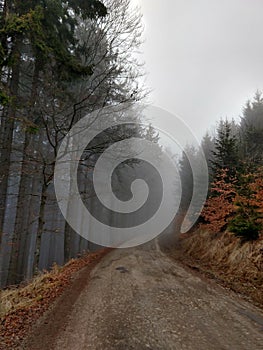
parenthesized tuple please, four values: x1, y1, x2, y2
(201, 168, 263, 237)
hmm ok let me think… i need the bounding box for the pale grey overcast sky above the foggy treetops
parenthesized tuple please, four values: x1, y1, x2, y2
(132, 0, 263, 138)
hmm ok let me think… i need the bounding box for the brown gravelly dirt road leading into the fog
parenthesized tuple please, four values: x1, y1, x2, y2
(23, 243, 263, 350)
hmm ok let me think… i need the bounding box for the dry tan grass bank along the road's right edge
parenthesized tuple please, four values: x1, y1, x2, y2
(177, 231, 263, 307)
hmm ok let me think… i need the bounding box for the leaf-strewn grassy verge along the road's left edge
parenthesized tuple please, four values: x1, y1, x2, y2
(0, 249, 110, 350)
